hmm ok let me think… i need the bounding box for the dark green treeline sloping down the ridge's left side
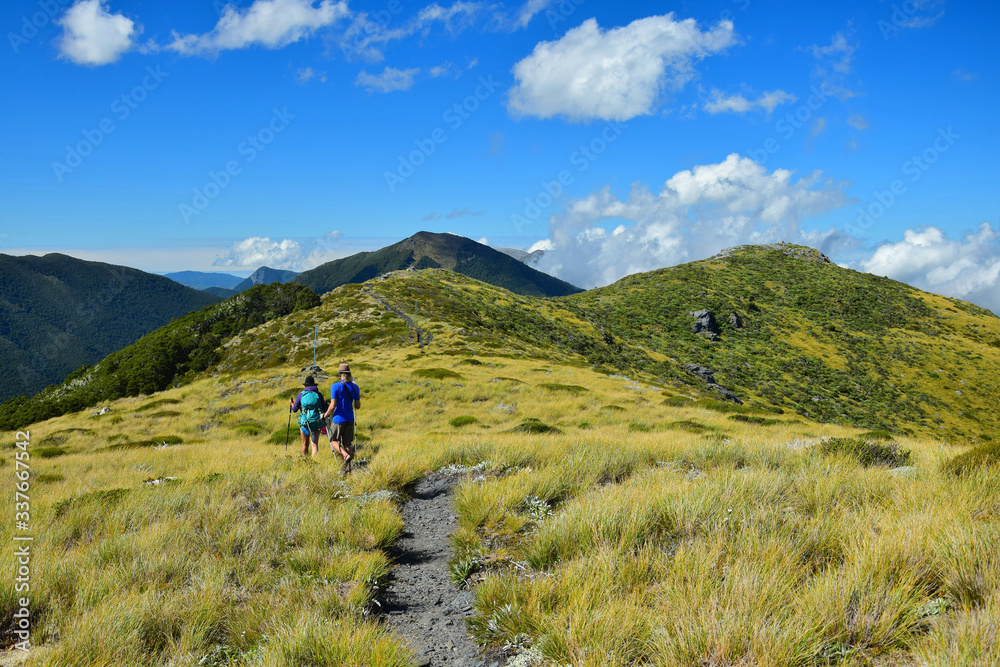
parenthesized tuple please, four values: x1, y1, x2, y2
(0, 283, 320, 430)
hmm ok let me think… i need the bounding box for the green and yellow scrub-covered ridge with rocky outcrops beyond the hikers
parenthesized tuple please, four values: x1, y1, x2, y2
(220, 246, 1000, 441)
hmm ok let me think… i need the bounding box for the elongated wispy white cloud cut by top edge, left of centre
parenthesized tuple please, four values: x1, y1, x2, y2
(166, 0, 351, 56)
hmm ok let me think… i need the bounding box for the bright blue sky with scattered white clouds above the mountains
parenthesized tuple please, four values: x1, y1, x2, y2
(0, 0, 1000, 309)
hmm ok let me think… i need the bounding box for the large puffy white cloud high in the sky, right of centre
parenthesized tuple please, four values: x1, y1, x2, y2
(507, 14, 736, 121)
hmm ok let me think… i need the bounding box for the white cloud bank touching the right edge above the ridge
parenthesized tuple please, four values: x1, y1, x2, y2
(860, 222, 1000, 312)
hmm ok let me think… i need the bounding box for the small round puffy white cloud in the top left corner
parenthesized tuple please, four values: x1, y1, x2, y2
(56, 0, 137, 65)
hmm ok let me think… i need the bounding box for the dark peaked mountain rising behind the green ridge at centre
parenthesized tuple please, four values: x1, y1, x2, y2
(295, 232, 583, 296)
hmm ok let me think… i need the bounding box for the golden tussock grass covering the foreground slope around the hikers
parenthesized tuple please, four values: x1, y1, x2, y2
(0, 350, 1000, 667)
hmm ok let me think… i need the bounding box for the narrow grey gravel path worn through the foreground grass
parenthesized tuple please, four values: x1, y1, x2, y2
(382, 473, 501, 667)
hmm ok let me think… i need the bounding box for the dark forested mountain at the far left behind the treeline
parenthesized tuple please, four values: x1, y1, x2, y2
(0, 253, 219, 400)
